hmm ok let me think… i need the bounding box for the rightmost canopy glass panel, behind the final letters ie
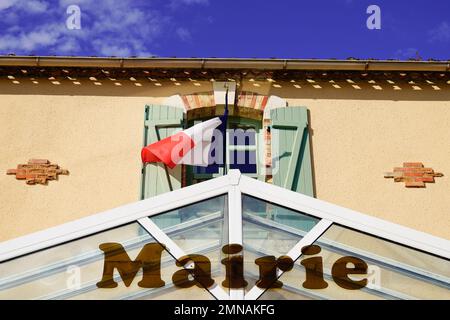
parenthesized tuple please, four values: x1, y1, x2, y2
(264, 225, 450, 299)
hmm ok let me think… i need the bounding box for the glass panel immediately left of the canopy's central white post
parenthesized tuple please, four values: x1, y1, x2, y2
(150, 195, 228, 294)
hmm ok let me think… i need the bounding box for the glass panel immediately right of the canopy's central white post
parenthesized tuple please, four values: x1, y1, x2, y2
(242, 195, 319, 299)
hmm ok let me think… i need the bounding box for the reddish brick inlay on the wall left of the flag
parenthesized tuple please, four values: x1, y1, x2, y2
(6, 159, 69, 185)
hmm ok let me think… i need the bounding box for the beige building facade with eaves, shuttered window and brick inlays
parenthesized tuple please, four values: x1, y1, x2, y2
(0, 57, 450, 298)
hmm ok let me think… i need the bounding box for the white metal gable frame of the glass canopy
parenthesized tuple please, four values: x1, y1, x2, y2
(0, 170, 450, 300)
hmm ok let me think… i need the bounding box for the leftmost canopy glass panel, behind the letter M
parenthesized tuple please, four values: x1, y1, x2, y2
(0, 223, 213, 299)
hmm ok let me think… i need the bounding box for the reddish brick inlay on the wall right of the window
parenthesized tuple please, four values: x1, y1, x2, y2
(384, 162, 443, 188)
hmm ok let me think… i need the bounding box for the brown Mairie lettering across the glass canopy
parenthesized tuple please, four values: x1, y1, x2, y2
(97, 243, 368, 290)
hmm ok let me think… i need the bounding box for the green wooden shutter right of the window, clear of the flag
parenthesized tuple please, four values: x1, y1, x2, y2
(270, 107, 314, 197)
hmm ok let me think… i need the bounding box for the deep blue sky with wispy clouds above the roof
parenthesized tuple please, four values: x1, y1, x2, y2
(0, 0, 450, 60)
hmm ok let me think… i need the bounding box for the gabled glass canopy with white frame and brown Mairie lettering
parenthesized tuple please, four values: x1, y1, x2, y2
(0, 170, 450, 300)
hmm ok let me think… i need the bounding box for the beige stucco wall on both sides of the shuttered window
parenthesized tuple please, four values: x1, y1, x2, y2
(0, 75, 450, 241)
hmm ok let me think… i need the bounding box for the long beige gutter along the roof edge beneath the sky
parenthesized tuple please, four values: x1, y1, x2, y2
(0, 56, 450, 72)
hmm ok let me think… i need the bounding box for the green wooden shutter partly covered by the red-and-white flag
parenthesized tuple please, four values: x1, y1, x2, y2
(141, 105, 184, 199)
